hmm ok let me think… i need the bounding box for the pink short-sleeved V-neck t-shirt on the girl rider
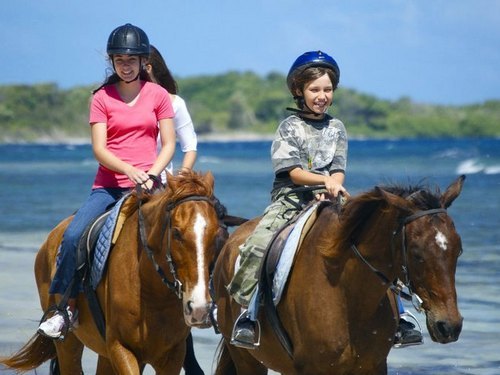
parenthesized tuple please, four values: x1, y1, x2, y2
(89, 82, 174, 189)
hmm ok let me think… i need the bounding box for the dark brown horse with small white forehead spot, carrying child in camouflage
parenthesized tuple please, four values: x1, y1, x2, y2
(214, 176, 465, 375)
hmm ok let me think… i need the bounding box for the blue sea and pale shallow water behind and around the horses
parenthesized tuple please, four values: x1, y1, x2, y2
(0, 139, 500, 375)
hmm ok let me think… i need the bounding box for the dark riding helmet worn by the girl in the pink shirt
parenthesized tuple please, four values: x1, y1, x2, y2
(107, 23, 151, 57)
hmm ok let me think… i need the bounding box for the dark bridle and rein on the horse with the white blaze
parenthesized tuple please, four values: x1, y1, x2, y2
(137, 185, 214, 299)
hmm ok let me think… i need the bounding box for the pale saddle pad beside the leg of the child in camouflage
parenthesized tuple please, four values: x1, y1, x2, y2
(273, 202, 319, 305)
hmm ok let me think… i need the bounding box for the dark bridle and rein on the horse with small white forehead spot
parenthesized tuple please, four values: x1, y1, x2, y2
(351, 208, 447, 312)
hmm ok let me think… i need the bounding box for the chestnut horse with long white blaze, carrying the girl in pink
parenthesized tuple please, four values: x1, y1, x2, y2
(0, 172, 219, 375)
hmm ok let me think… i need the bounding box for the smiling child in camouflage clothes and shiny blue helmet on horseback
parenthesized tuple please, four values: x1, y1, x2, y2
(228, 51, 348, 348)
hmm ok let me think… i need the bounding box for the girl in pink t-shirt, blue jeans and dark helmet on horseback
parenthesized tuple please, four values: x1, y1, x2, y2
(38, 24, 175, 338)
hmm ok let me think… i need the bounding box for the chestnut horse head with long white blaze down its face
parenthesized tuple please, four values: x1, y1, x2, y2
(140, 172, 219, 327)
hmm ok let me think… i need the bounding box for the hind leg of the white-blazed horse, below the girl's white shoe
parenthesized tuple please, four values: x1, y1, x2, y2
(51, 332, 83, 375)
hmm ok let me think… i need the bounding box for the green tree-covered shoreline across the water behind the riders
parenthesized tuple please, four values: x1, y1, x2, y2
(0, 72, 500, 142)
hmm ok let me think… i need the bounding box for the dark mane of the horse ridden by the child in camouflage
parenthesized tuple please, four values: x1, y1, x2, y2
(325, 184, 441, 256)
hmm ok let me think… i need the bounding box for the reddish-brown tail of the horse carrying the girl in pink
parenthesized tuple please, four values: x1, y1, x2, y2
(0, 333, 56, 373)
